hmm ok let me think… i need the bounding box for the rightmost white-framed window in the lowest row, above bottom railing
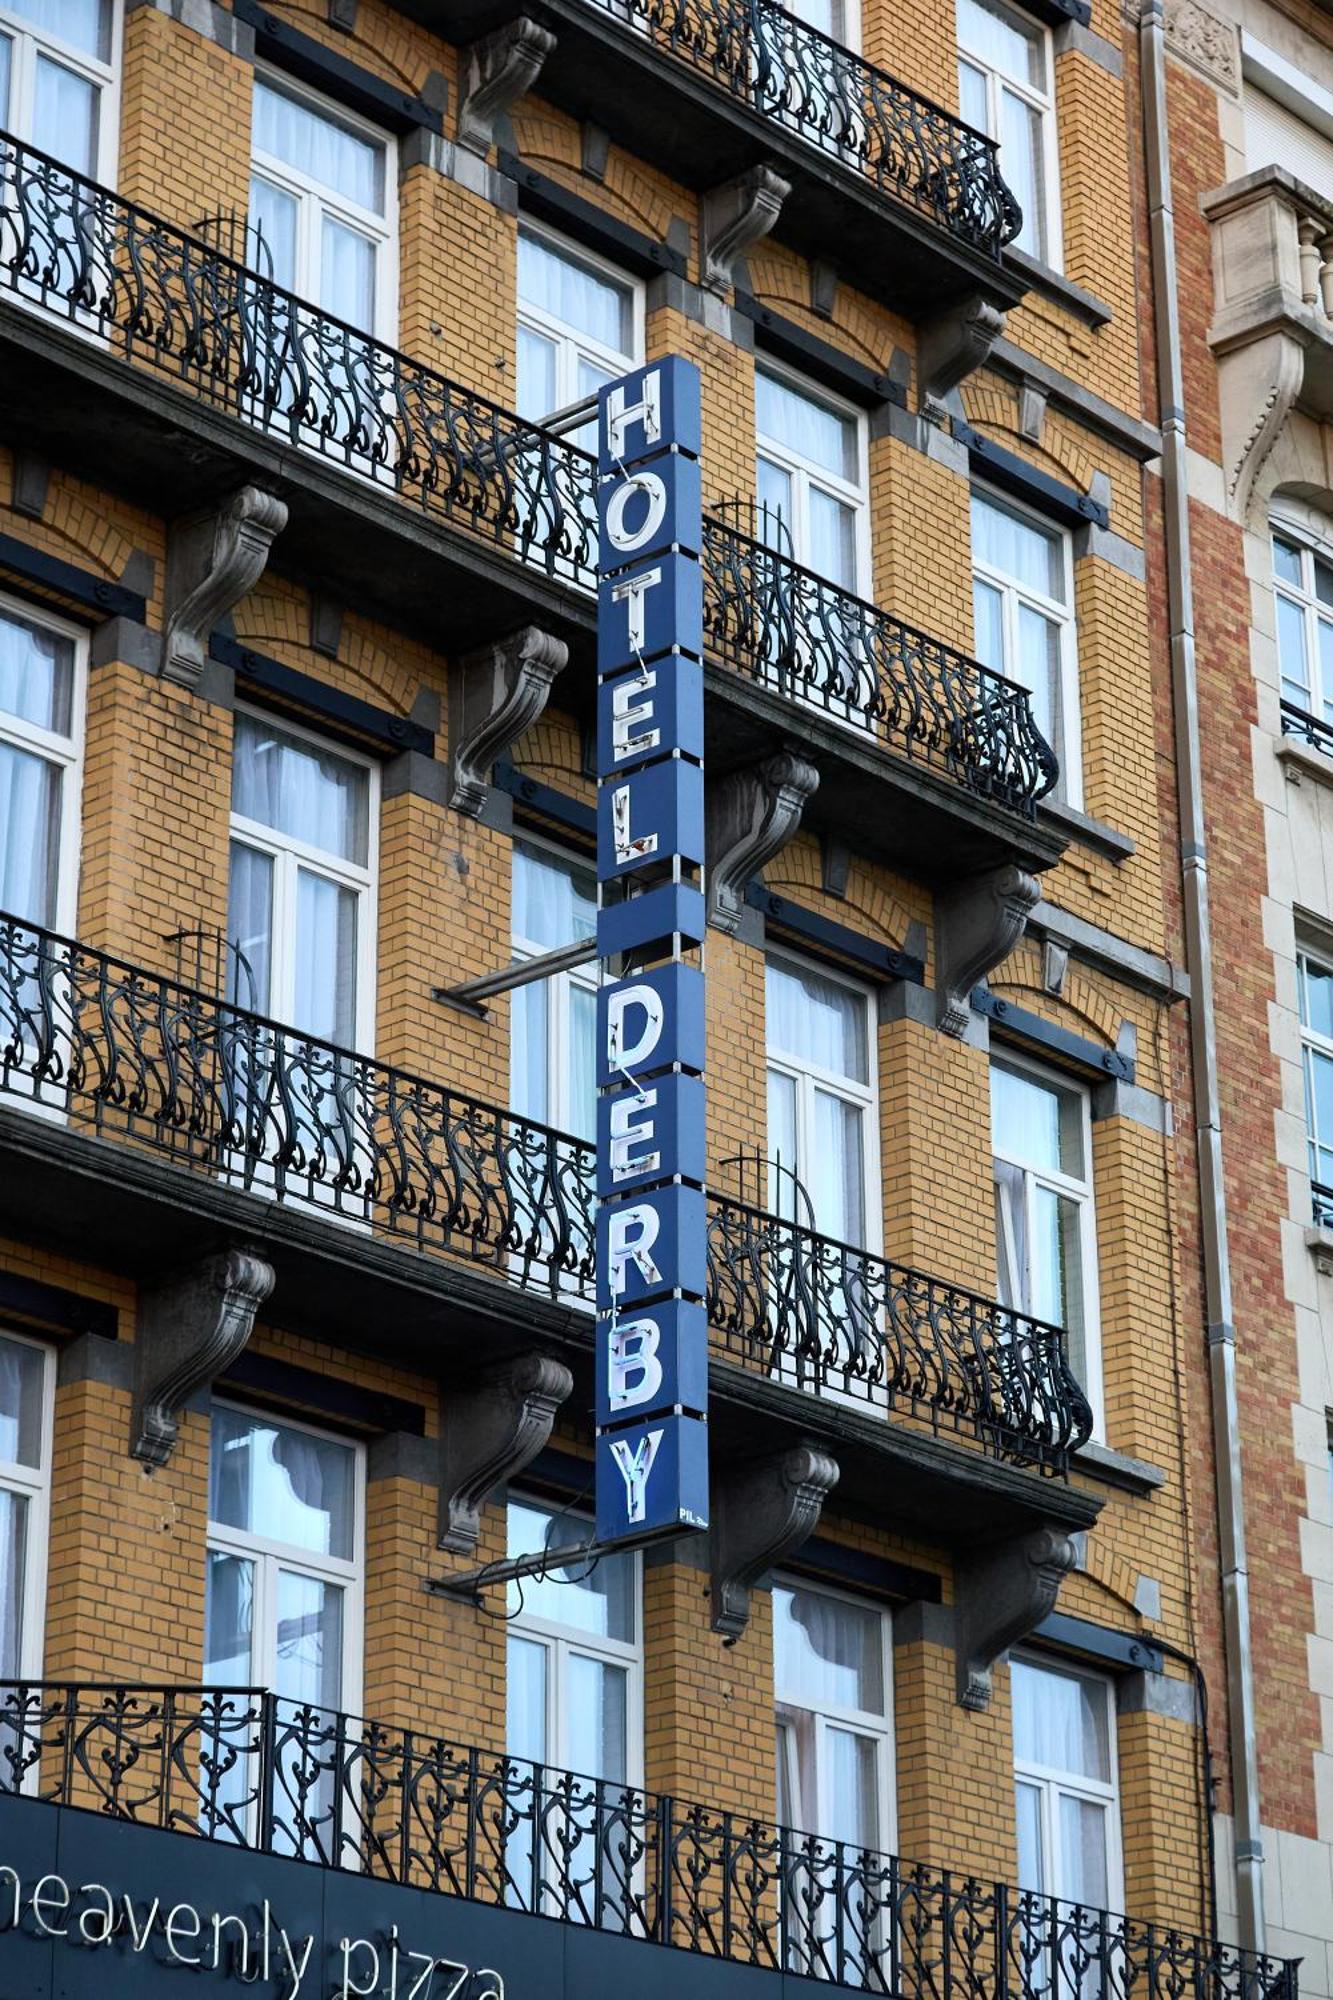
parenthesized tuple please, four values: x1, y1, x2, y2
(1011, 1658, 1123, 1922)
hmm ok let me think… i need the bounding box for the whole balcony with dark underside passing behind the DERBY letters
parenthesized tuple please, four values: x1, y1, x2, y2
(0, 918, 1097, 1540)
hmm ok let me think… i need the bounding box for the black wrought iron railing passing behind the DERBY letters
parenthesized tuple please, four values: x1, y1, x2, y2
(0, 916, 1091, 1472)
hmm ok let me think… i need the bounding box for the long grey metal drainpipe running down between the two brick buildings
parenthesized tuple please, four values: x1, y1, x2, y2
(1139, 0, 1265, 1952)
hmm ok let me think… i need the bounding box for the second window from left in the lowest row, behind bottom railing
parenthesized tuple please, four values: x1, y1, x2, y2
(204, 1404, 364, 1852)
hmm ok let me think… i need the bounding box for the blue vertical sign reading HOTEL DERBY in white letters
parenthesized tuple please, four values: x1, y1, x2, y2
(596, 356, 709, 1542)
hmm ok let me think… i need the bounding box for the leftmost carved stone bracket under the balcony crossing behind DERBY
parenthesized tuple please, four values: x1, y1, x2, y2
(130, 1248, 272, 1466)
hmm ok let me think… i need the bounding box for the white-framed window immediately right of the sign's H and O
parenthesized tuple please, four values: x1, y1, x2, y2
(755, 368, 871, 596)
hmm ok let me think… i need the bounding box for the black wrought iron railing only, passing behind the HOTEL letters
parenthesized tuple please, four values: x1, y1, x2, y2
(0, 131, 1057, 814)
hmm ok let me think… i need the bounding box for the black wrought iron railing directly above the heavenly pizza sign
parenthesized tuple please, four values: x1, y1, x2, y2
(0, 1682, 1297, 2000)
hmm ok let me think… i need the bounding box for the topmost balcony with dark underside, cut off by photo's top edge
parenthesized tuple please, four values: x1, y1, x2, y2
(426, 0, 1027, 318)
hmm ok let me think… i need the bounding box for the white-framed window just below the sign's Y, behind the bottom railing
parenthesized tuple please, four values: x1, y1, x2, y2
(504, 1504, 642, 1928)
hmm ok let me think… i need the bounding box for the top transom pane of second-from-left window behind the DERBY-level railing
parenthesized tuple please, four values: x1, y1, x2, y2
(232, 714, 370, 868)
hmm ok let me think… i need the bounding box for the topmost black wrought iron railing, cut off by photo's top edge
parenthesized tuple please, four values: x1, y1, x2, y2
(580, 0, 1023, 258)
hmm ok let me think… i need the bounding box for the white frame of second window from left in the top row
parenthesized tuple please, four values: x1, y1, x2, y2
(250, 64, 398, 346)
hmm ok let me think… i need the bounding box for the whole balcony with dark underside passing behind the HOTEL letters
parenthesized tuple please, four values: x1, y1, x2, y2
(0, 140, 1065, 880)
